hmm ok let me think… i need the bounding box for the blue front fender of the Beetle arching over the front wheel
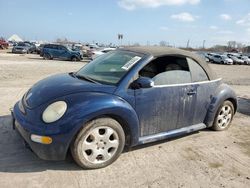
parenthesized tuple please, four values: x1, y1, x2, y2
(63, 92, 139, 146)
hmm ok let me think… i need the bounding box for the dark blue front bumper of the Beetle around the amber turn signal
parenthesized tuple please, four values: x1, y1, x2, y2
(11, 106, 69, 160)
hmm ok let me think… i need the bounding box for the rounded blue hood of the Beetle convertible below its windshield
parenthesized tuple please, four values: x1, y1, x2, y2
(24, 73, 116, 108)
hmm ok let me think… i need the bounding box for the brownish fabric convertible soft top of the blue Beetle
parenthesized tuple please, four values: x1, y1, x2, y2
(124, 46, 218, 80)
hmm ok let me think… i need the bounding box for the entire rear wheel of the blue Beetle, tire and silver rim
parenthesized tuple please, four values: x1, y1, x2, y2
(211, 101, 235, 131)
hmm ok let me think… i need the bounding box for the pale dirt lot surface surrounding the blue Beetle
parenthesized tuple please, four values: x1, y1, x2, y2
(0, 53, 250, 188)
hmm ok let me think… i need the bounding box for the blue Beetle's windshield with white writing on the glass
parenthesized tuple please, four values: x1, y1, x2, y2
(76, 51, 142, 85)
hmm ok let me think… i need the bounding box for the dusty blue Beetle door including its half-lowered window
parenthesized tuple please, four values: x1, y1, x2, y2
(135, 56, 196, 136)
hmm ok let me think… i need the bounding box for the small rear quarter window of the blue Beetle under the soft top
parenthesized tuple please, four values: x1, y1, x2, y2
(187, 58, 208, 82)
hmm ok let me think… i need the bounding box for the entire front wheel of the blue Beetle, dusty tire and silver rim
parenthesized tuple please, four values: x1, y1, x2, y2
(70, 118, 125, 169)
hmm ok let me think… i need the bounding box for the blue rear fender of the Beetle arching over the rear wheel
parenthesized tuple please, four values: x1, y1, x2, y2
(204, 83, 237, 127)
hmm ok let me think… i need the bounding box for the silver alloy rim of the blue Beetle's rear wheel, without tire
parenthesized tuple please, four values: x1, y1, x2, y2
(217, 105, 232, 129)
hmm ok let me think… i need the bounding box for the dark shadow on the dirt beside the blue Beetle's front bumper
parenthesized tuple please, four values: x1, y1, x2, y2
(0, 115, 82, 173)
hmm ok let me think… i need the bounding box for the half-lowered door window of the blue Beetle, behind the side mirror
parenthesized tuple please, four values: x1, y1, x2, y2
(139, 56, 191, 86)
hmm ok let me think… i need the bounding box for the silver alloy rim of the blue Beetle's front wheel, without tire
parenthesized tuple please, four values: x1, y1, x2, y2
(82, 127, 119, 164)
